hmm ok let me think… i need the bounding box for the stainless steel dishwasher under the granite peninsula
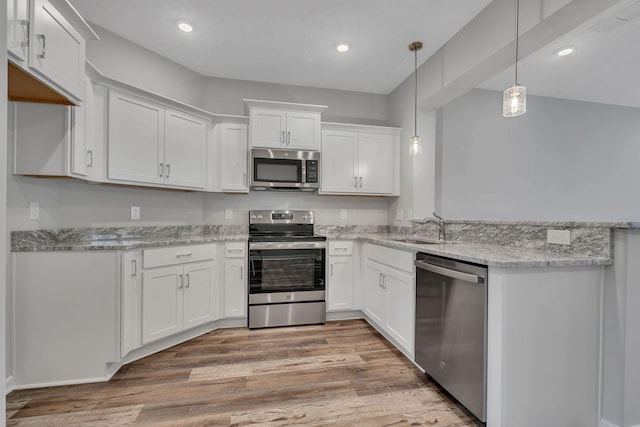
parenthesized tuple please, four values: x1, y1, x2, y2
(415, 253, 488, 422)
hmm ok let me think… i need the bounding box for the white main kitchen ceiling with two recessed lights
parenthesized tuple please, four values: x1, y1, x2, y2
(70, 0, 491, 94)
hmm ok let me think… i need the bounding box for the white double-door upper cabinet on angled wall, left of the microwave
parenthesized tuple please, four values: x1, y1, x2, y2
(107, 90, 209, 189)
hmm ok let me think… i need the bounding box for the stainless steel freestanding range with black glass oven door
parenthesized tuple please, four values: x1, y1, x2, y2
(248, 211, 326, 329)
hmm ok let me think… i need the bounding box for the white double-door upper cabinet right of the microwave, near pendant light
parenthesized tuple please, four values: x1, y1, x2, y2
(320, 124, 399, 195)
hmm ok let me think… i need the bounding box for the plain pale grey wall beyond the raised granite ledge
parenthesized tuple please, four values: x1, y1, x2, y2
(437, 89, 640, 221)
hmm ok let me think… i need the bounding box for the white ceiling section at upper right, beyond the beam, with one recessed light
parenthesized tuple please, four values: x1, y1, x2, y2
(480, 0, 640, 107)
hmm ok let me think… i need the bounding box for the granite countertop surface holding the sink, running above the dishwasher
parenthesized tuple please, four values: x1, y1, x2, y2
(326, 234, 612, 268)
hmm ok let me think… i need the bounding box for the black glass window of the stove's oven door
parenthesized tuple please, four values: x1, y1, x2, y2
(249, 249, 325, 293)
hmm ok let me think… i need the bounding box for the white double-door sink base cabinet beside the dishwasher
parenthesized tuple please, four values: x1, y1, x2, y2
(363, 244, 415, 358)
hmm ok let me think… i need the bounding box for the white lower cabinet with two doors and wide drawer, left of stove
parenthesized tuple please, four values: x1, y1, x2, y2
(142, 244, 217, 344)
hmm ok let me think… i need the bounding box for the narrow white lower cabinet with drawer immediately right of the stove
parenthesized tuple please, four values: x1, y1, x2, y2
(327, 241, 354, 311)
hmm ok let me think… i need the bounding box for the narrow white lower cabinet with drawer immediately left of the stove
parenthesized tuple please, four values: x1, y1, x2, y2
(223, 242, 247, 317)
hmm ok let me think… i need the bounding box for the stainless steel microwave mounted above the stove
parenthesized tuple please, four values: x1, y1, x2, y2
(250, 148, 320, 191)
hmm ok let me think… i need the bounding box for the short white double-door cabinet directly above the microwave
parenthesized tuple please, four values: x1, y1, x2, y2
(244, 99, 327, 151)
